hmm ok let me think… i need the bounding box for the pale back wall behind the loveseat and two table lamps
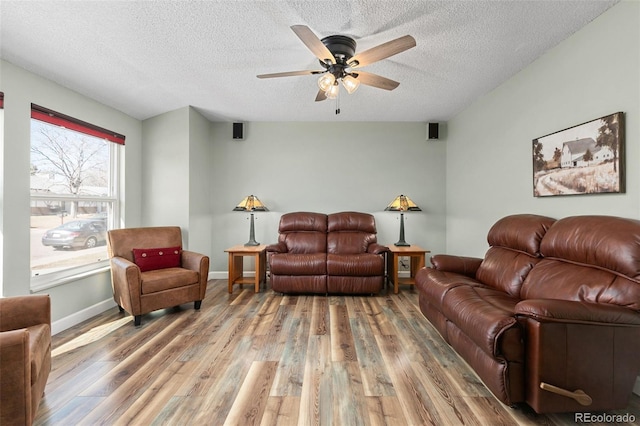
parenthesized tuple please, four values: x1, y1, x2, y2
(211, 122, 446, 271)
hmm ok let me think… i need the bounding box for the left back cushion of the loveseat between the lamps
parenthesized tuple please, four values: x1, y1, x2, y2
(278, 212, 327, 254)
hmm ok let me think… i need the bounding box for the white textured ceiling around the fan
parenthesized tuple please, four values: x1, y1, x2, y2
(0, 0, 618, 122)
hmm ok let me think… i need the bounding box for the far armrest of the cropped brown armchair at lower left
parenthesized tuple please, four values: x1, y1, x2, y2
(0, 294, 51, 331)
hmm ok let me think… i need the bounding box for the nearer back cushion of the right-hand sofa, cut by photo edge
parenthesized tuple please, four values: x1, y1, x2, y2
(521, 216, 640, 310)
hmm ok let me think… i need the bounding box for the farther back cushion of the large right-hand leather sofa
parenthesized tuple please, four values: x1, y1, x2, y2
(476, 214, 555, 297)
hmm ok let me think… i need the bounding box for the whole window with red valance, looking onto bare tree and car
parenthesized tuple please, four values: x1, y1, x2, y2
(30, 105, 124, 288)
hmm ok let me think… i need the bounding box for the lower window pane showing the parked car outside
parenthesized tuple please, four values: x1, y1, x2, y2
(30, 200, 111, 276)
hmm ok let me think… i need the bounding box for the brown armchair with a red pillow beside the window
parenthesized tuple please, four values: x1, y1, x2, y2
(107, 226, 209, 326)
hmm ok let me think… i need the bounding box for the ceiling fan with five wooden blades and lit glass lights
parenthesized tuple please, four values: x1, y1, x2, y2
(257, 25, 416, 107)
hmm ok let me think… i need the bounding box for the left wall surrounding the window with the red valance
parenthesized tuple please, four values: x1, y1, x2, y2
(0, 61, 141, 322)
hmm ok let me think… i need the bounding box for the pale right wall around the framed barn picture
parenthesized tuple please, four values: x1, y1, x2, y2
(446, 1, 640, 256)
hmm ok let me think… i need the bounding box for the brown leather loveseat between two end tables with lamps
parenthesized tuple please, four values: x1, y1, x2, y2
(267, 212, 388, 294)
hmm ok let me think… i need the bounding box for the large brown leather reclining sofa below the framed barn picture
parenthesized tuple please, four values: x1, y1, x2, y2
(416, 215, 640, 413)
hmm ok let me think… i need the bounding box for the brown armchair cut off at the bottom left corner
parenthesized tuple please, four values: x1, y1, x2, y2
(0, 295, 51, 425)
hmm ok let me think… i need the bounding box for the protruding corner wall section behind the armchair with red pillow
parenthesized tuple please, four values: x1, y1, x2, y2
(142, 107, 211, 255)
